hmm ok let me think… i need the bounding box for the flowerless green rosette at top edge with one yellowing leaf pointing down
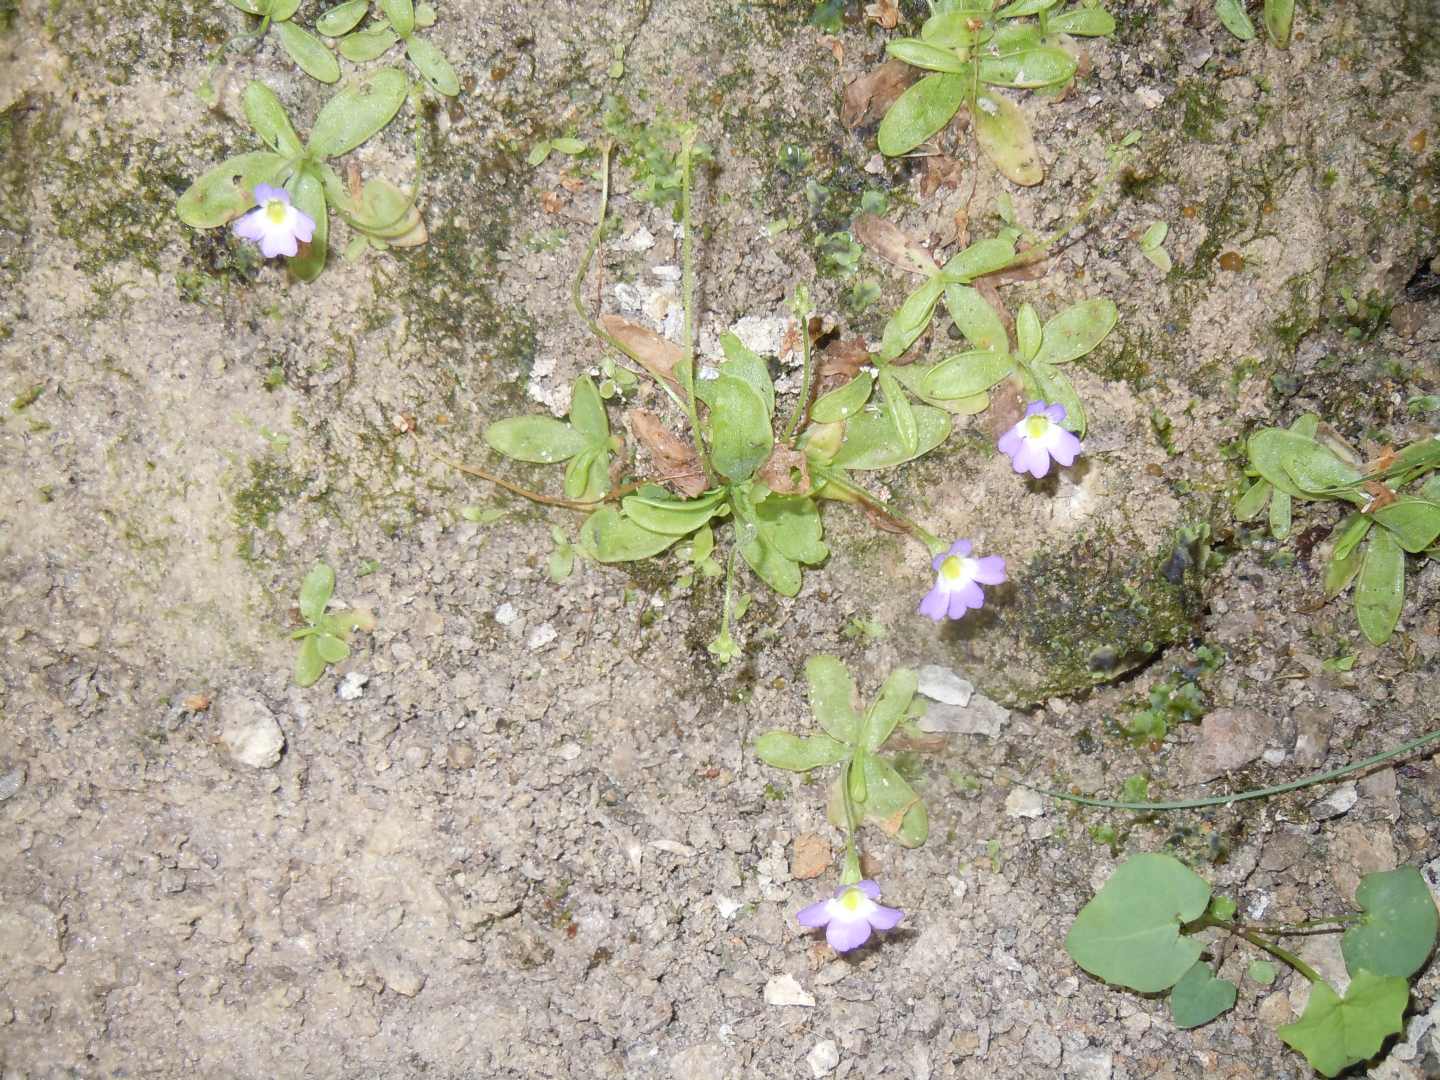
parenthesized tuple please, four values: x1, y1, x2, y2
(878, 0, 1115, 186)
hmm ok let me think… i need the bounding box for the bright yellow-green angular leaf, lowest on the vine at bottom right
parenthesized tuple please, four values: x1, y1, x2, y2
(1276, 971, 1410, 1076)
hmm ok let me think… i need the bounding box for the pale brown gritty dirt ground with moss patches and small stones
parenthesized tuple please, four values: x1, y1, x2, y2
(0, 0, 1440, 1080)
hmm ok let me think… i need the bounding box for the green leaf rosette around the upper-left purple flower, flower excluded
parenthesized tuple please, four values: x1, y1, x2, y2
(176, 68, 425, 281)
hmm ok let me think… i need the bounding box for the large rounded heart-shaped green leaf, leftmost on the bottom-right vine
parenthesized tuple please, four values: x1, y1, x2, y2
(1066, 854, 1210, 994)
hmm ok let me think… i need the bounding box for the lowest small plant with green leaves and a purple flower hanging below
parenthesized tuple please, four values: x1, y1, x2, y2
(755, 655, 930, 952)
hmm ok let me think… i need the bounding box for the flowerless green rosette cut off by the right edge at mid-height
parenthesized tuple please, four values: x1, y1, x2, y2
(1236, 413, 1440, 645)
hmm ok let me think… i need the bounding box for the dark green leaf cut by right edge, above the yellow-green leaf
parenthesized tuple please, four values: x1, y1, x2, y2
(1341, 867, 1437, 979)
